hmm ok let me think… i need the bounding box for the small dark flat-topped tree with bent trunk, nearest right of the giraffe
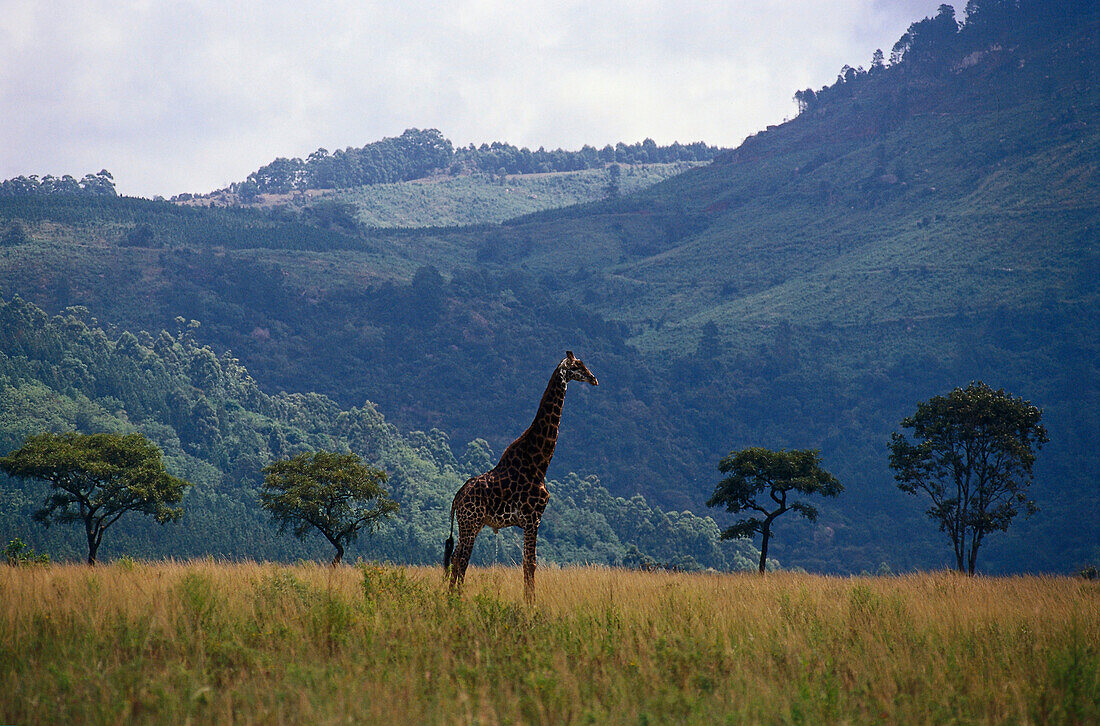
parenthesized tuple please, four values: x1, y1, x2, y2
(706, 447, 844, 574)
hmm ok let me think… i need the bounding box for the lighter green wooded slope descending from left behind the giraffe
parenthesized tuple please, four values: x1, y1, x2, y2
(0, 298, 754, 570)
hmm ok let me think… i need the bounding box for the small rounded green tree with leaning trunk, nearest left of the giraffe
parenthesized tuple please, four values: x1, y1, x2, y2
(260, 451, 398, 567)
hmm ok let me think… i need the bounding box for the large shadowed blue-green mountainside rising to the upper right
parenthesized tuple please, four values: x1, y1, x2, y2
(0, 2, 1100, 572)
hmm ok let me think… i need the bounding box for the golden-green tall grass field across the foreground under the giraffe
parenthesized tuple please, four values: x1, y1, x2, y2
(0, 560, 1100, 724)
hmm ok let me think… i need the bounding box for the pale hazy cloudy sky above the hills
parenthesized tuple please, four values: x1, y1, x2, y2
(0, 0, 946, 196)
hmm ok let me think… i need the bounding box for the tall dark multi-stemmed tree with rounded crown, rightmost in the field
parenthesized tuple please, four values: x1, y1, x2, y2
(890, 381, 1049, 575)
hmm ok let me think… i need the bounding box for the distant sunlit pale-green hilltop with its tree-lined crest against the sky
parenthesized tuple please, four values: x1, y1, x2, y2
(181, 129, 726, 232)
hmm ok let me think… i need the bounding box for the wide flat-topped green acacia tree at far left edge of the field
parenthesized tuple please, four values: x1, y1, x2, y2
(0, 432, 190, 564)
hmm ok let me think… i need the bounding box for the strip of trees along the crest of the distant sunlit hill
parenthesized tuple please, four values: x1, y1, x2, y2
(225, 129, 721, 201)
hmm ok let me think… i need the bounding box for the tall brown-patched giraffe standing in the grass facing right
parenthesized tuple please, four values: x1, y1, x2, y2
(443, 351, 600, 604)
